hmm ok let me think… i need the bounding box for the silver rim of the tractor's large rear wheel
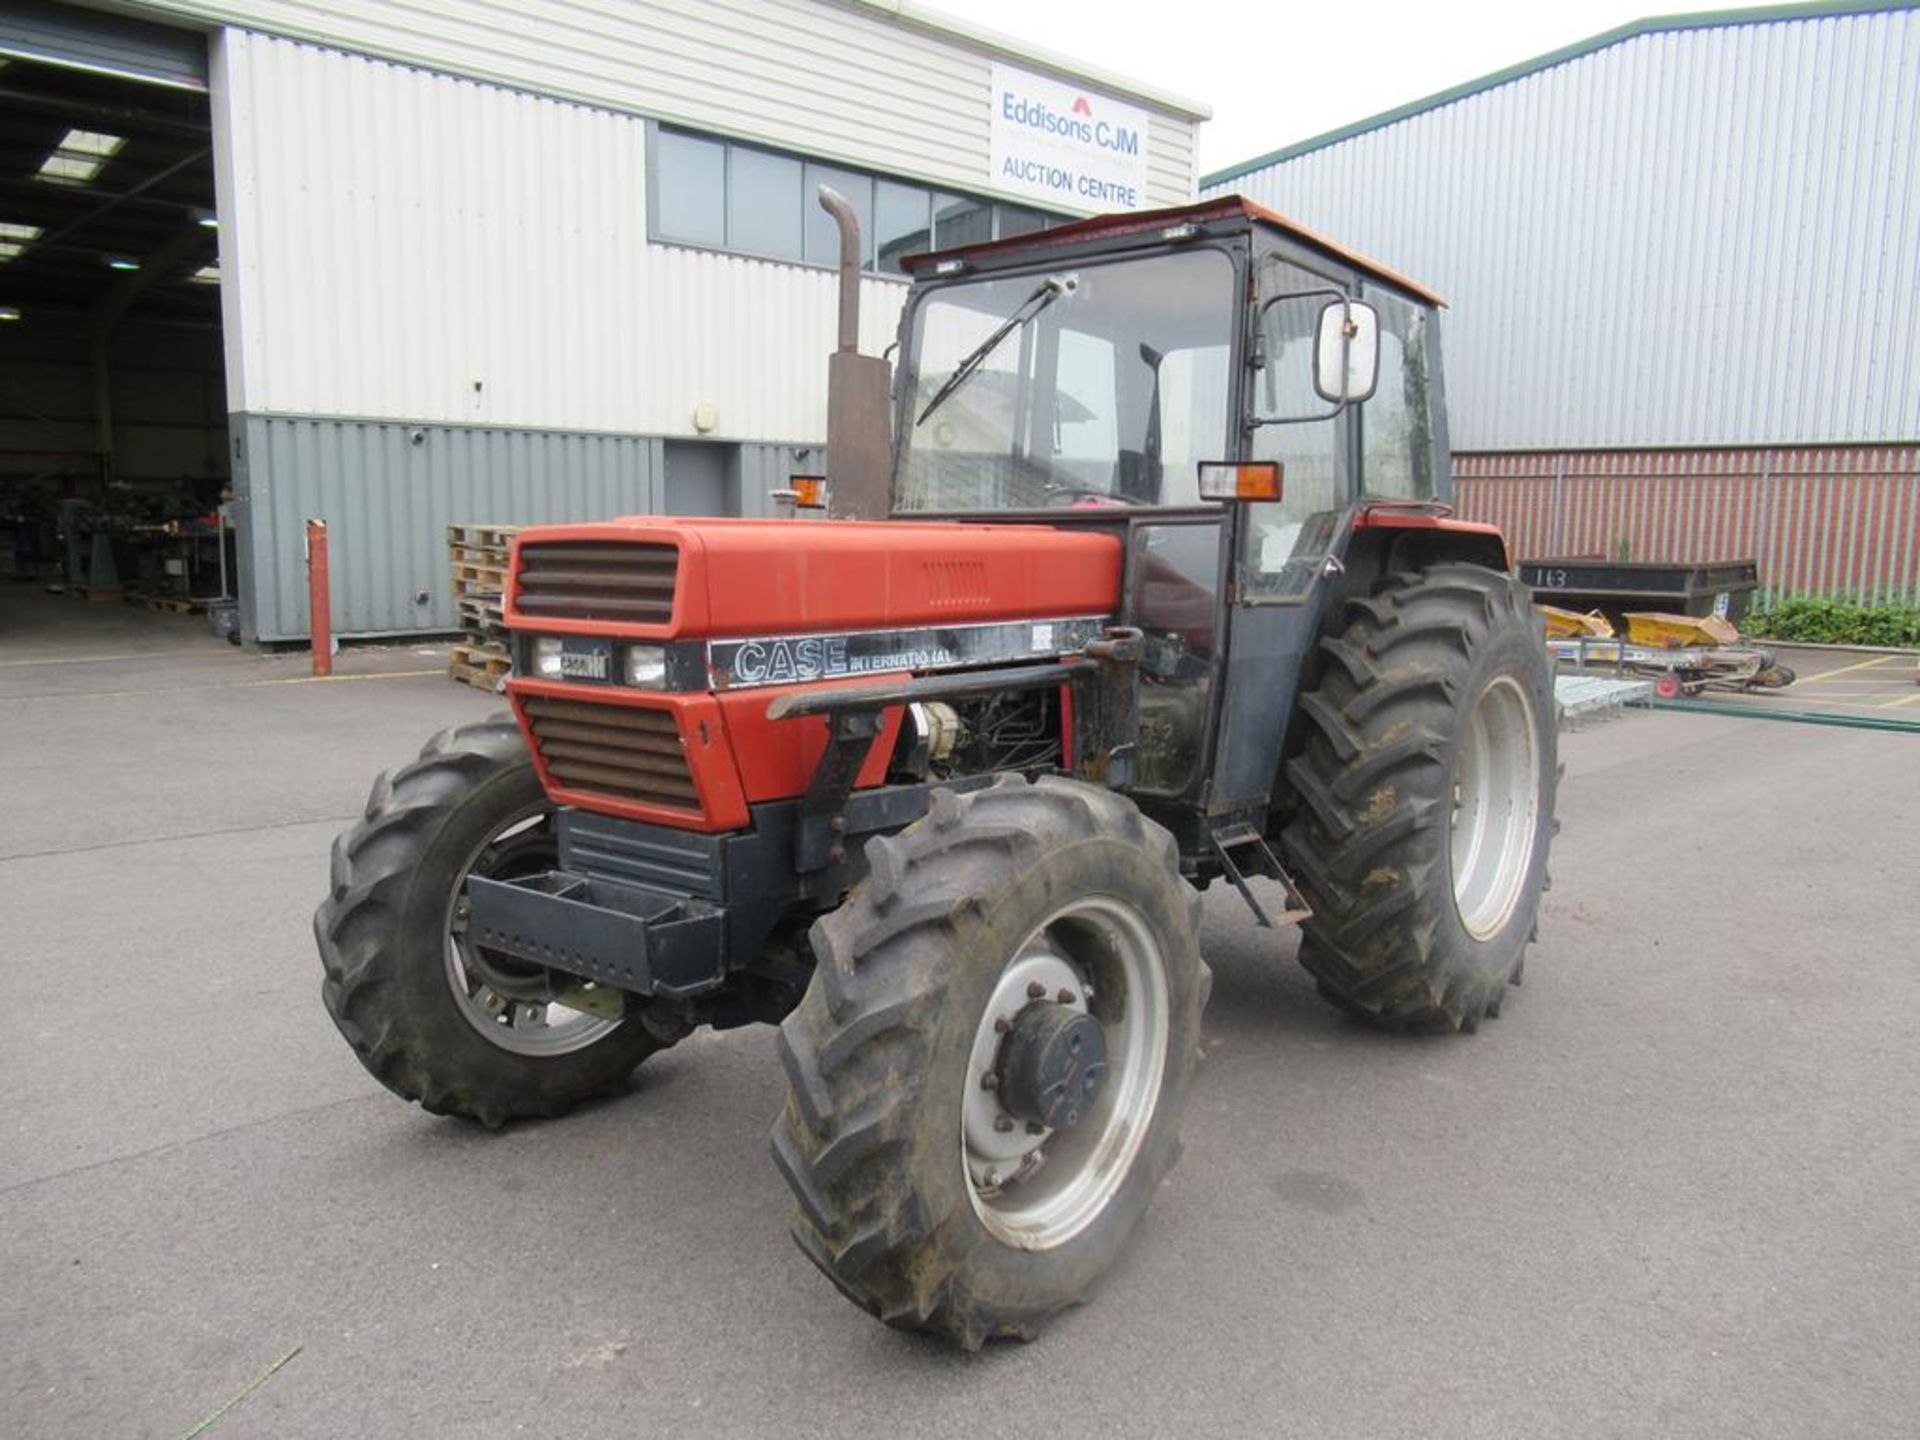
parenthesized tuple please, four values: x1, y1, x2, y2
(1452, 676, 1540, 941)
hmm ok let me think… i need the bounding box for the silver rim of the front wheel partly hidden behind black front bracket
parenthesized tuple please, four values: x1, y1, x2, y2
(445, 804, 620, 1056)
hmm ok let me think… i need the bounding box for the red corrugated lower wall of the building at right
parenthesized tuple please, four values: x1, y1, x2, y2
(1453, 445, 1920, 603)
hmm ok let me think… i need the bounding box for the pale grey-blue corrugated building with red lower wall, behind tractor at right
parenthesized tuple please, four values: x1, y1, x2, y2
(1202, 2, 1920, 599)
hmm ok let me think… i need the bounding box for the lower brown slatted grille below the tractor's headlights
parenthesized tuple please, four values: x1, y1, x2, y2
(524, 695, 701, 810)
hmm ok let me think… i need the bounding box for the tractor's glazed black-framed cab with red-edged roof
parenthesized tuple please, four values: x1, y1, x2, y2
(864, 198, 1505, 852)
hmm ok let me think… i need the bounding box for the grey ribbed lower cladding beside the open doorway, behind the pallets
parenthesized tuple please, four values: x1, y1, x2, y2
(232, 415, 660, 639)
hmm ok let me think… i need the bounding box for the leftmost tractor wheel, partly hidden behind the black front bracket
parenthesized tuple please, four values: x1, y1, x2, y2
(313, 716, 666, 1127)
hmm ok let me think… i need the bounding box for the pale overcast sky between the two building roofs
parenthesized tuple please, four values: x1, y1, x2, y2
(925, 0, 1738, 173)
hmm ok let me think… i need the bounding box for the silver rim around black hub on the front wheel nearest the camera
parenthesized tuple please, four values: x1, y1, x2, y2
(960, 897, 1169, 1250)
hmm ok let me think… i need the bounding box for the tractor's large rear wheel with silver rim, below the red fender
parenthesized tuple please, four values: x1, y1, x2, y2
(1283, 564, 1559, 1031)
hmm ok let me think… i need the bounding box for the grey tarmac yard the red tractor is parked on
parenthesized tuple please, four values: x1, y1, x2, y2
(0, 593, 1920, 1440)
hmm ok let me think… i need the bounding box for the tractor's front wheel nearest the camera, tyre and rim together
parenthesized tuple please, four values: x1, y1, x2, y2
(774, 776, 1208, 1350)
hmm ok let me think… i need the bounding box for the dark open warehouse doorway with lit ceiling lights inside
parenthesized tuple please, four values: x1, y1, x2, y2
(0, 4, 238, 649)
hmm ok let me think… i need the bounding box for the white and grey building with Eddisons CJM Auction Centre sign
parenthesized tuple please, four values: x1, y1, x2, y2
(0, 0, 1206, 641)
